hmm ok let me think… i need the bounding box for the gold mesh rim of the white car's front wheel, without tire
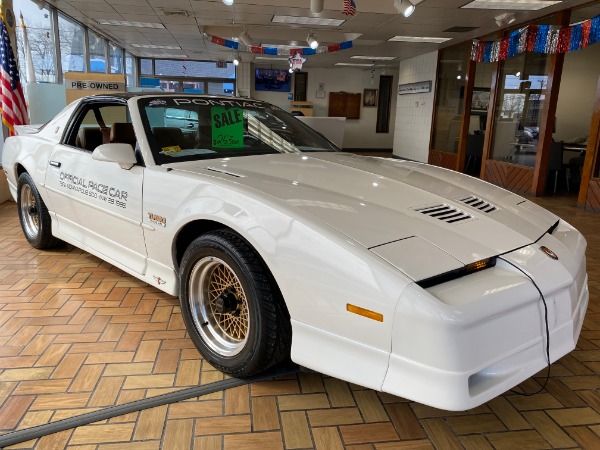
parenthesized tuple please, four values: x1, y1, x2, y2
(189, 257, 250, 356)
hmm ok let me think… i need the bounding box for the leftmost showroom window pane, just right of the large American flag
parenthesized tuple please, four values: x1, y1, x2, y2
(13, 0, 56, 83)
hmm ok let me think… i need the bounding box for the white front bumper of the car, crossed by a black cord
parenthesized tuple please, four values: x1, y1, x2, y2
(382, 228, 589, 410)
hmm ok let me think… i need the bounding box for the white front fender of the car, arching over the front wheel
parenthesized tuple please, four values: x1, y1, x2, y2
(143, 169, 411, 352)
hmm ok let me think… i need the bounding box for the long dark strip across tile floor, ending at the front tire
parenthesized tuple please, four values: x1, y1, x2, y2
(0, 366, 298, 448)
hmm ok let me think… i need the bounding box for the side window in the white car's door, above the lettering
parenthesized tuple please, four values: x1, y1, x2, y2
(66, 104, 136, 152)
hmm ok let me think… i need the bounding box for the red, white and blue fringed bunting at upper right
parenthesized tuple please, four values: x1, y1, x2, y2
(471, 16, 600, 62)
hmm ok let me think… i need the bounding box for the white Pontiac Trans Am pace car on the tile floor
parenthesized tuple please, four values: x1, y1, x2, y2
(2, 94, 589, 410)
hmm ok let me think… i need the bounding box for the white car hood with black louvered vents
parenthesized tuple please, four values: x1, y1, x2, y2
(165, 153, 558, 264)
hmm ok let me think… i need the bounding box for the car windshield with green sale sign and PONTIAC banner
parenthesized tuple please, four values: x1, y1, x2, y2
(138, 96, 339, 164)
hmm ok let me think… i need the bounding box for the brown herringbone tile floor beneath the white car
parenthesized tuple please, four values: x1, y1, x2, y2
(0, 194, 600, 450)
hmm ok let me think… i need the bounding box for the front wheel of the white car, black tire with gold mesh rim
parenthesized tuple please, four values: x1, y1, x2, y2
(180, 230, 291, 377)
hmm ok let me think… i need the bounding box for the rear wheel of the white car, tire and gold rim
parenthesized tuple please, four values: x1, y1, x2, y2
(17, 172, 62, 250)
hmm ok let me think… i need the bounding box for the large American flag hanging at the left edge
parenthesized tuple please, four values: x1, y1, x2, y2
(0, 15, 29, 136)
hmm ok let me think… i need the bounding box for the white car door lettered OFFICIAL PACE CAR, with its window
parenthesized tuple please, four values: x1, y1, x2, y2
(46, 101, 146, 274)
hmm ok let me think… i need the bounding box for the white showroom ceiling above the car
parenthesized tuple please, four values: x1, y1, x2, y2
(49, 0, 585, 67)
